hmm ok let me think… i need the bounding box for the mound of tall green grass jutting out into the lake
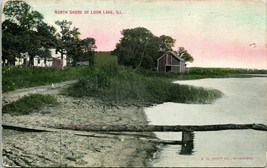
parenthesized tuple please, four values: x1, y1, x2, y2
(67, 64, 221, 104)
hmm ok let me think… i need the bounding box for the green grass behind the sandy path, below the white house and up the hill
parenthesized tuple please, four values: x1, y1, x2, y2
(2, 52, 116, 92)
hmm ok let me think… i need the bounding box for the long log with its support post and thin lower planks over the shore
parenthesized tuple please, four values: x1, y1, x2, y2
(2, 123, 267, 145)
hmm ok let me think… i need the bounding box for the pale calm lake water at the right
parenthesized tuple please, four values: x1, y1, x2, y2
(145, 77, 267, 167)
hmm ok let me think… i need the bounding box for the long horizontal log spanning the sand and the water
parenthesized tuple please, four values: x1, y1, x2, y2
(2, 123, 267, 132)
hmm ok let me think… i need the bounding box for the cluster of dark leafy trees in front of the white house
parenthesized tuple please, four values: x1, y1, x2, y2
(2, 1, 96, 66)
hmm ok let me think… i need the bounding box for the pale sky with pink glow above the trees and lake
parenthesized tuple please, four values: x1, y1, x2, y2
(6, 0, 267, 69)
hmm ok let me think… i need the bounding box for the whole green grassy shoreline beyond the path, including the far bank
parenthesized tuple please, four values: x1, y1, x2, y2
(2, 52, 267, 106)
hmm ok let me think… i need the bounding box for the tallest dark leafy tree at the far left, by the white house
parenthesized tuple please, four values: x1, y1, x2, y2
(2, 1, 53, 65)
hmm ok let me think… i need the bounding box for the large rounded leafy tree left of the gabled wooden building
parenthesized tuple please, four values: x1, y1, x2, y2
(112, 27, 158, 69)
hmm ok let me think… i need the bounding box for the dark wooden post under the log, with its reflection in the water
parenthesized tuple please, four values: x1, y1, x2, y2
(179, 131, 194, 155)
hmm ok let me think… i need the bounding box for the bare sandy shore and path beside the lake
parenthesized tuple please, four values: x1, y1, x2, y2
(2, 81, 156, 167)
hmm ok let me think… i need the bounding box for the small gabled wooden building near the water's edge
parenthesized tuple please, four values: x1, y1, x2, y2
(157, 51, 186, 73)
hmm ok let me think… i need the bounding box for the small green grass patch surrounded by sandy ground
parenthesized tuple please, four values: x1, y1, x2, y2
(2, 94, 58, 115)
